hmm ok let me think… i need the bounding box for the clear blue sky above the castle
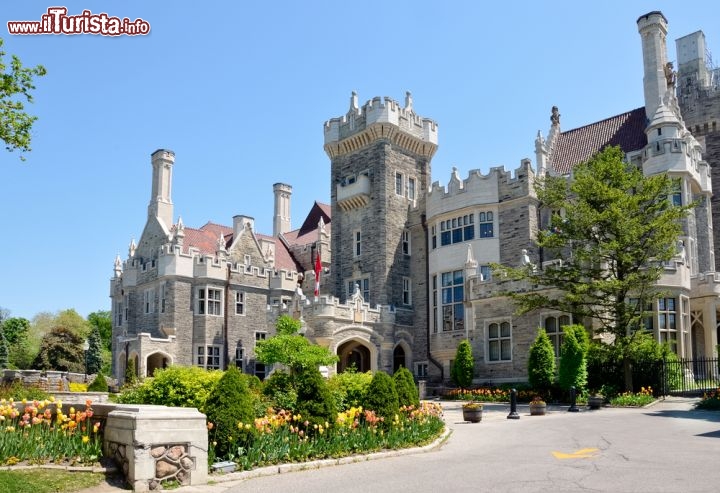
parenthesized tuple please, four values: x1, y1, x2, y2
(0, 0, 720, 318)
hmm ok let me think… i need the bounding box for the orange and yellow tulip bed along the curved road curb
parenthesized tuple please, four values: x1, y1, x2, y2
(208, 402, 445, 470)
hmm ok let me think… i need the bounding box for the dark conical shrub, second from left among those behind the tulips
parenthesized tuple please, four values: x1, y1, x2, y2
(295, 367, 337, 426)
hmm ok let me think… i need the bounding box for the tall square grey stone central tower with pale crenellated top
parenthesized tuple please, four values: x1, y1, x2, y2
(325, 92, 437, 330)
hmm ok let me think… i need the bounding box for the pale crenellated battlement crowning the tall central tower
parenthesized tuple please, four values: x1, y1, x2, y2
(324, 92, 438, 153)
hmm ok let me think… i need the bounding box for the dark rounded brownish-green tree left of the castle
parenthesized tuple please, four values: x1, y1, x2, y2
(33, 327, 85, 373)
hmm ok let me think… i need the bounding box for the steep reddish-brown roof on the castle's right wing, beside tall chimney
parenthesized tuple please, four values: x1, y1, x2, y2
(550, 107, 647, 175)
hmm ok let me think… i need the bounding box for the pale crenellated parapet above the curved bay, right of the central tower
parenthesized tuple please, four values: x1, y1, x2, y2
(427, 159, 535, 213)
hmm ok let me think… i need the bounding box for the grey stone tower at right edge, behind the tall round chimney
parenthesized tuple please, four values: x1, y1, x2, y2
(675, 31, 720, 259)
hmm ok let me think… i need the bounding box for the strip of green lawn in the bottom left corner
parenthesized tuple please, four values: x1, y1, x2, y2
(0, 469, 105, 493)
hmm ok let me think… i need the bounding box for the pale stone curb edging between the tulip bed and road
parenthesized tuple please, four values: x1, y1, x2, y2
(208, 425, 452, 483)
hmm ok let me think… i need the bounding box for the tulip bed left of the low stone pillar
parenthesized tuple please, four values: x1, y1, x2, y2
(0, 398, 102, 465)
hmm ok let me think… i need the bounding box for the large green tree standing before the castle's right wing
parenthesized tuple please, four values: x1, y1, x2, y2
(497, 147, 692, 388)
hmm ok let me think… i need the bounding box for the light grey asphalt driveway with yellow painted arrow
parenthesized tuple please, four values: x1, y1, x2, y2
(212, 398, 720, 493)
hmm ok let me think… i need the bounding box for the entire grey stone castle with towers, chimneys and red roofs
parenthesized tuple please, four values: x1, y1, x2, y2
(110, 12, 720, 382)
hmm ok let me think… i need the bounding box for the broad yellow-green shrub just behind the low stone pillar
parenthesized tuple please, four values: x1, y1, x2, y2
(118, 364, 224, 412)
